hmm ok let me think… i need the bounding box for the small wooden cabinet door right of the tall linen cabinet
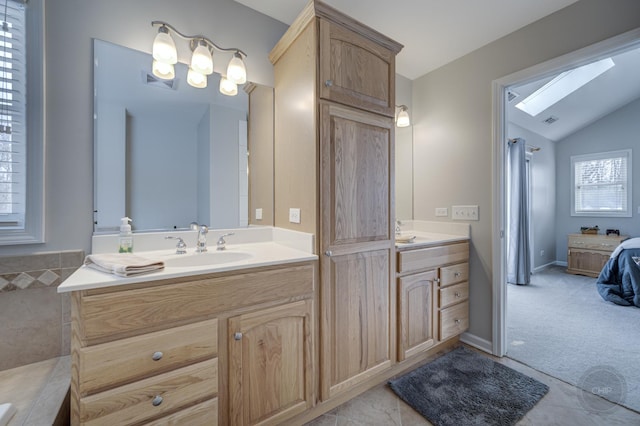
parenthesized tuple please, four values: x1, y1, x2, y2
(398, 270, 437, 361)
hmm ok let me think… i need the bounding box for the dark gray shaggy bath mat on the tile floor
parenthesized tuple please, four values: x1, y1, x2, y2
(389, 347, 549, 426)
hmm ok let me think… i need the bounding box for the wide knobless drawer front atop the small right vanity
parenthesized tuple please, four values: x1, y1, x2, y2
(397, 242, 469, 273)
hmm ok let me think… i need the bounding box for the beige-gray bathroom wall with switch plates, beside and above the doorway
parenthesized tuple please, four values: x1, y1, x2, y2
(412, 0, 640, 341)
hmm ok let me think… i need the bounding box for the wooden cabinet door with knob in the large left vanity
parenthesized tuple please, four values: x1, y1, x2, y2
(229, 300, 314, 425)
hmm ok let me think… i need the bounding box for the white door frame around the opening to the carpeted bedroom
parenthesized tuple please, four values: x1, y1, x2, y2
(492, 28, 640, 356)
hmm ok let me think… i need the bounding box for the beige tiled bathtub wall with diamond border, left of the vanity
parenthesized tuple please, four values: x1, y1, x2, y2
(0, 250, 84, 371)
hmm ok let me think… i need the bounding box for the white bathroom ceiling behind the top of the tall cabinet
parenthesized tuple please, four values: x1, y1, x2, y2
(236, 0, 577, 80)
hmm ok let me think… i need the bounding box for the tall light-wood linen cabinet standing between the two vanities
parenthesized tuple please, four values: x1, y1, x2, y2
(270, 1, 402, 401)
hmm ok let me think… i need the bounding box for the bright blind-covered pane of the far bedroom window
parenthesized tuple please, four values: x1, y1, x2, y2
(574, 155, 628, 213)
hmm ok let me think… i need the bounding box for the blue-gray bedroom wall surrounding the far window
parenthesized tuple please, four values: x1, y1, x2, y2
(556, 99, 640, 262)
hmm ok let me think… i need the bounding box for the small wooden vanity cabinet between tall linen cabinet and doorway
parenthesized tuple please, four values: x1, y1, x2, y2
(397, 242, 469, 360)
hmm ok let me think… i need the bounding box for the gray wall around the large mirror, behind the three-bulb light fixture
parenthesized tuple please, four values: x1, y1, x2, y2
(0, 0, 287, 255)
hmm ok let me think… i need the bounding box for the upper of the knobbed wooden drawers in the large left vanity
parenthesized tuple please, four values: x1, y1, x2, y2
(78, 319, 218, 395)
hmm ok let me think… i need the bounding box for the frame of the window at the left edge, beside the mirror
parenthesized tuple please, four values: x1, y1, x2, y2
(0, 0, 45, 246)
